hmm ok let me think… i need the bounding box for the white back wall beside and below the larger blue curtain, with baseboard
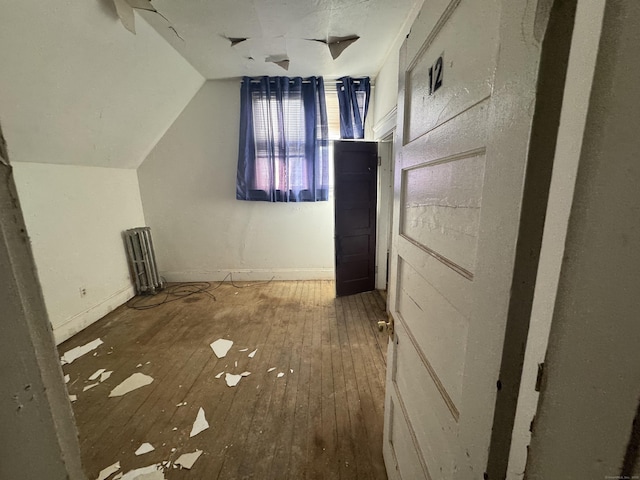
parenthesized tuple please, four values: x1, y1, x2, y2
(138, 81, 334, 281)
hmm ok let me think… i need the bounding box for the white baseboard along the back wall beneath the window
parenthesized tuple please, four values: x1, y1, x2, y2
(160, 268, 335, 282)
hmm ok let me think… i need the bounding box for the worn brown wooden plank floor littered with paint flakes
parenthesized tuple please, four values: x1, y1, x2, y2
(60, 281, 387, 480)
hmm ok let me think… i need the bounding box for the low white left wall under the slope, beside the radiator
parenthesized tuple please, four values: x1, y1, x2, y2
(14, 163, 144, 343)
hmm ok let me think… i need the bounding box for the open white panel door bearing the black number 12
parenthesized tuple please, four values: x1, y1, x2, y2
(384, 0, 544, 480)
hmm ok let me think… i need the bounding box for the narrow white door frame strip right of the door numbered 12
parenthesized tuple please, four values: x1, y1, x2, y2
(507, 1, 624, 478)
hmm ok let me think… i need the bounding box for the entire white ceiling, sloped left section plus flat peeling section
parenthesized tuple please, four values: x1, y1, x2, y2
(0, 0, 423, 168)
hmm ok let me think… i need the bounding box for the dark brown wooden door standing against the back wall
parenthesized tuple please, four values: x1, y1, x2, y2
(333, 141, 378, 296)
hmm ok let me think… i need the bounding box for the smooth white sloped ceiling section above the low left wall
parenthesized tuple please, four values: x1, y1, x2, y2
(0, 0, 204, 168)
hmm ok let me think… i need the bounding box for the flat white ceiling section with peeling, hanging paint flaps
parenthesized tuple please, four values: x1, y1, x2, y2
(141, 0, 423, 79)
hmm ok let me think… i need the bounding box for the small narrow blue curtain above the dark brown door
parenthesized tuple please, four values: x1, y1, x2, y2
(336, 77, 371, 138)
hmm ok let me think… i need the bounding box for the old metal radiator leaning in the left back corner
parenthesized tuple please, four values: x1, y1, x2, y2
(124, 227, 164, 295)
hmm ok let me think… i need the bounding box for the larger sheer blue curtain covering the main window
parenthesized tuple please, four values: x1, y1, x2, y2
(236, 77, 329, 202)
